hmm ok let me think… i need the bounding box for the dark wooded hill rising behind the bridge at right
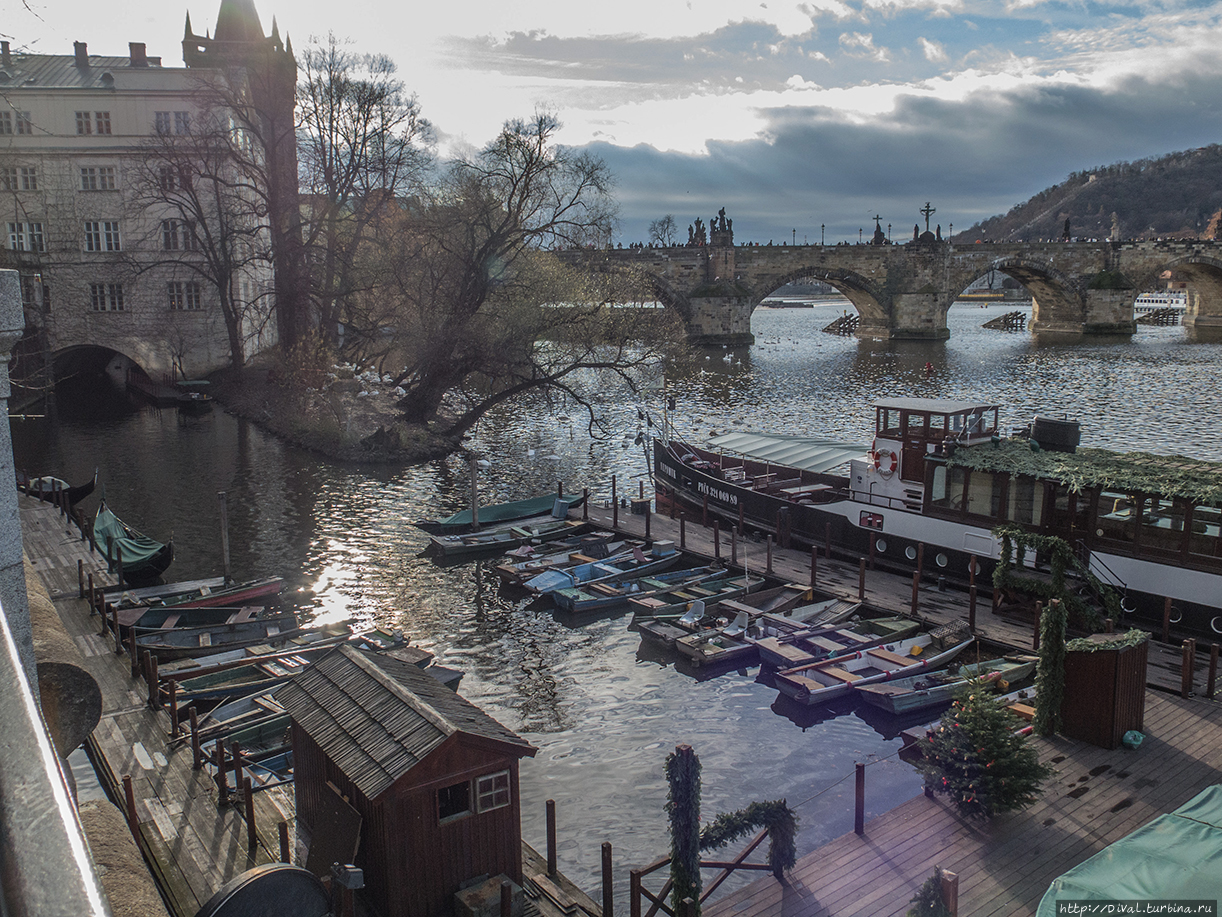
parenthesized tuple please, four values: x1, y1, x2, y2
(954, 144, 1222, 242)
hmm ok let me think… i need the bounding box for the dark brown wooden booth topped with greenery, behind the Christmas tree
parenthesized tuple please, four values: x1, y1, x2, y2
(1061, 633, 1149, 748)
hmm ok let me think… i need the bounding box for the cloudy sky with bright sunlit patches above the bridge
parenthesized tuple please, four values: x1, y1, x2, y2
(9, 0, 1222, 243)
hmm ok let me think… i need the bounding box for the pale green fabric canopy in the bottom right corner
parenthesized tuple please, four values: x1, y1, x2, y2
(1036, 785, 1222, 917)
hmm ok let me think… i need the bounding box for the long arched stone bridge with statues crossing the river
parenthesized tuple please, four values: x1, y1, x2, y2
(562, 230, 1222, 344)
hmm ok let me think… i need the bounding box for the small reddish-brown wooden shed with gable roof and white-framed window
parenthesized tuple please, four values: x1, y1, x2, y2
(277, 647, 535, 917)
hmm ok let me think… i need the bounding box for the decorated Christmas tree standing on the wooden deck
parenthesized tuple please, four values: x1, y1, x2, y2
(919, 680, 1052, 818)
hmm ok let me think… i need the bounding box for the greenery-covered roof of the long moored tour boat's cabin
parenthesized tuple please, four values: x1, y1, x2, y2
(947, 439, 1222, 506)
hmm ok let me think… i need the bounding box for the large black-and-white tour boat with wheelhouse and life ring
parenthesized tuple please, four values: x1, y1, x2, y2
(654, 397, 1222, 639)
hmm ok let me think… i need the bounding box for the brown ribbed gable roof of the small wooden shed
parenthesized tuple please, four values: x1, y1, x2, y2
(276, 646, 535, 800)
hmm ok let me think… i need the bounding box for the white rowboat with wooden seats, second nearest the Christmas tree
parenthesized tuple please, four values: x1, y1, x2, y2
(774, 626, 975, 705)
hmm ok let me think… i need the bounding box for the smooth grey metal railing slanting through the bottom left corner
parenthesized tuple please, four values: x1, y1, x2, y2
(0, 599, 110, 917)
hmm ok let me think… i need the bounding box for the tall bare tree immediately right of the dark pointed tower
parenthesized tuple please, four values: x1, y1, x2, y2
(297, 34, 431, 347)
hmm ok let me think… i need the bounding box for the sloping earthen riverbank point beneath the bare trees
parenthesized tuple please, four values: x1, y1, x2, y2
(211, 364, 459, 465)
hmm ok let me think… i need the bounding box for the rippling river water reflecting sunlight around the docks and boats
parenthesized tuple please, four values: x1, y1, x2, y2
(13, 302, 1222, 907)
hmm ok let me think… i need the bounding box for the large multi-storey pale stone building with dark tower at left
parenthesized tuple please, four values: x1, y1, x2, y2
(0, 0, 299, 388)
